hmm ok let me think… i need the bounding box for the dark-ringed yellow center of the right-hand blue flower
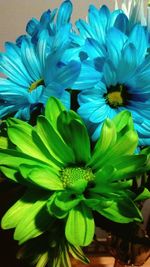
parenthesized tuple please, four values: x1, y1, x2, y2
(104, 84, 129, 108)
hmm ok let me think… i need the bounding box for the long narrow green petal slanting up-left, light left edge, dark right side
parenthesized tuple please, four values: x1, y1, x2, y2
(36, 116, 75, 164)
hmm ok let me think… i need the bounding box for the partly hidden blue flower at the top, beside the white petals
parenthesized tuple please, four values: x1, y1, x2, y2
(74, 5, 124, 45)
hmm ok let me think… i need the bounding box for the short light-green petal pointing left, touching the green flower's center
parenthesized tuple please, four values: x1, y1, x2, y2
(19, 164, 63, 190)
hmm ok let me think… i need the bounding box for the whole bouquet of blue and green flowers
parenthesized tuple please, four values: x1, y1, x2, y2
(0, 0, 150, 267)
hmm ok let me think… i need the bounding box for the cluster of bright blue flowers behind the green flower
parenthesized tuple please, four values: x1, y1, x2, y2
(0, 0, 150, 146)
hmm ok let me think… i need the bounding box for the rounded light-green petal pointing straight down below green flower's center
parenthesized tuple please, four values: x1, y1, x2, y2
(65, 203, 95, 246)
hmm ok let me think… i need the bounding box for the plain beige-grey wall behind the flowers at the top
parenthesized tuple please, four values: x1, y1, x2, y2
(0, 0, 114, 50)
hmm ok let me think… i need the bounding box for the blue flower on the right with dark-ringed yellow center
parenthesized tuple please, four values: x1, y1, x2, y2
(78, 25, 150, 145)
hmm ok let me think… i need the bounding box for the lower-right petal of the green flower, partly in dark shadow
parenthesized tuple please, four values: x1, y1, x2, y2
(96, 194, 143, 223)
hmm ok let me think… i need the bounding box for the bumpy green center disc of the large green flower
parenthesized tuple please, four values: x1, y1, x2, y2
(61, 167, 95, 189)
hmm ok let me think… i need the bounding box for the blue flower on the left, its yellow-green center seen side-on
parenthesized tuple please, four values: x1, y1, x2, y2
(0, 28, 80, 120)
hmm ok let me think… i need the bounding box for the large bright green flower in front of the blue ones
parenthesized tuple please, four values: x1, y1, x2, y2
(0, 98, 147, 249)
